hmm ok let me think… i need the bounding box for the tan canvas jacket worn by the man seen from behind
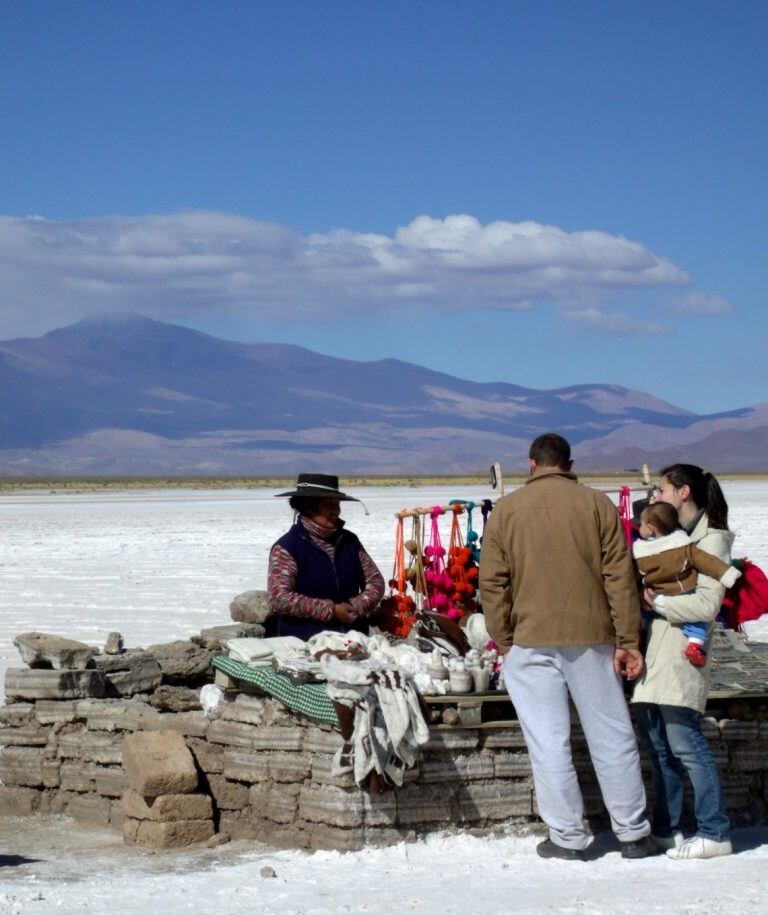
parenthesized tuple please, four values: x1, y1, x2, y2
(480, 468, 640, 652)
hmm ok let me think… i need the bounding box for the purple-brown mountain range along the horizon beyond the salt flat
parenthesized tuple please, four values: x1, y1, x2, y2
(0, 315, 768, 475)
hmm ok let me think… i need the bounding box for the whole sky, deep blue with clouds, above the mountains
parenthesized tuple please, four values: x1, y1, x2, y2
(0, 0, 768, 412)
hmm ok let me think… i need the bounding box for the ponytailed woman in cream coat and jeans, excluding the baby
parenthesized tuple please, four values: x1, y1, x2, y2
(632, 464, 733, 859)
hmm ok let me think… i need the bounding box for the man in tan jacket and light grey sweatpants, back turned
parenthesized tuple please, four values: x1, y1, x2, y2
(480, 433, 656, 858)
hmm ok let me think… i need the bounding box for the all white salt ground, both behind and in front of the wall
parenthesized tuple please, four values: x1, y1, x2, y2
(0, 481, 768, 915)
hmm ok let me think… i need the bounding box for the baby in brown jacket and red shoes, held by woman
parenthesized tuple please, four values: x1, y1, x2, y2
(632, 502, 741, 667)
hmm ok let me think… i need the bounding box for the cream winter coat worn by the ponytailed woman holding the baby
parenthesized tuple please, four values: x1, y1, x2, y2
(632, 515, 733, 712)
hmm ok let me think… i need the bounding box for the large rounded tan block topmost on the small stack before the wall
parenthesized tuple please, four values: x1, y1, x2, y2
(123, 731, 197, 797)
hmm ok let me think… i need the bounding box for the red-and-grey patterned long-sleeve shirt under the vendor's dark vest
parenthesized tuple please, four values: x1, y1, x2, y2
(267, 515, 384, 623)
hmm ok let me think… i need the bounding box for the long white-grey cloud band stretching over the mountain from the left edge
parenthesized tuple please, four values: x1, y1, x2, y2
(0, 211, 715, 336)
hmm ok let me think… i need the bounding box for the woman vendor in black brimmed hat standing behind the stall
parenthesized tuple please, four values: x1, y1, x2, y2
(267, 473, 384, 641)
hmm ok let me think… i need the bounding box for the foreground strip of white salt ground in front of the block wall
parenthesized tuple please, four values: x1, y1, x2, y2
(0, 817, 768, 915)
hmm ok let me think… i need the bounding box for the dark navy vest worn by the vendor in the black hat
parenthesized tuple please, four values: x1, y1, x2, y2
(276, 521, 368, 641)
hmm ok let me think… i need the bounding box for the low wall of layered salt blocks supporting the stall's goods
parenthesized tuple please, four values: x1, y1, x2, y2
(0, 688, 768, 850)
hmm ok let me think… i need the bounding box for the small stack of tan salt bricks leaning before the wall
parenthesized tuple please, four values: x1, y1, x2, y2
(123, 731, 215, 848)
